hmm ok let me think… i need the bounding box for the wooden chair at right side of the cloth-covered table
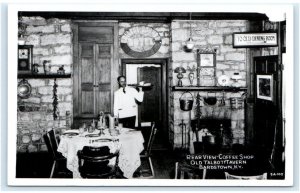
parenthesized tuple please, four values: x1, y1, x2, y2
(138, 122, 157, 178)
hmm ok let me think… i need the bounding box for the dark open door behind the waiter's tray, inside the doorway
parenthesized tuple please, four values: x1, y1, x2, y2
(138, 67, 162, 125)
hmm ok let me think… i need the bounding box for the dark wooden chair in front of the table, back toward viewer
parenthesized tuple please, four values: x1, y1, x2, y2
(77, 142, 119, 178)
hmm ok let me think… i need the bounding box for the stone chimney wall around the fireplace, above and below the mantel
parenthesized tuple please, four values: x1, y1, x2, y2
(170, 20, 249, 148)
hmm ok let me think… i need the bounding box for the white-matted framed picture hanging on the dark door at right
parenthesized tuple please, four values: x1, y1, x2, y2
(256, 75, 273, 101)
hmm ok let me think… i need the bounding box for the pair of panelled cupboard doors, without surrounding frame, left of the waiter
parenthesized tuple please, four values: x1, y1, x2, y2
(78, 43, 112, 117)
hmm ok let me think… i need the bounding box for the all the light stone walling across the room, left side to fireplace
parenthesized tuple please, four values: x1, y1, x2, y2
(17, 17, 253, 152)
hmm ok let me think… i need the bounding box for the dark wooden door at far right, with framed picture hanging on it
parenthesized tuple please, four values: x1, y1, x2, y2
(254, 56, 284, 175)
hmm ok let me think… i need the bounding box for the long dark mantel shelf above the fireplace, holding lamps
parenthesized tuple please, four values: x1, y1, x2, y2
(172, 86, 247, 92)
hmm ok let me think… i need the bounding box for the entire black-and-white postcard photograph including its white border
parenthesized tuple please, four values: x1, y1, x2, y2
(8, 1, 294, 187)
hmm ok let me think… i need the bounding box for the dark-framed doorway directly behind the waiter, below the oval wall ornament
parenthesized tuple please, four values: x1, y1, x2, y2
(121, 59, 169, 149)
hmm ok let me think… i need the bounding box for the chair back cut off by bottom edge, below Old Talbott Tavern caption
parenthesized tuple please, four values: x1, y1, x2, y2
(175, 162, 206, 179)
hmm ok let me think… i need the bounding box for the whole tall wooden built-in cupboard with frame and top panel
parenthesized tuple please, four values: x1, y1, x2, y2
(73, 22, 119, 128)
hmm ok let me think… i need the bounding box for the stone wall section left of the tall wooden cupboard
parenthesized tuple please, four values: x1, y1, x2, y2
(17, 17, 73, 152)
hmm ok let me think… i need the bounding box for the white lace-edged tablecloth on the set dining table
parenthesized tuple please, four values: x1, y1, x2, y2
(57, 128, 144, 178)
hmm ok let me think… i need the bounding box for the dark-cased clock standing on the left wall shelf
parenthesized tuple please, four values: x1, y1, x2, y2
(18, 45, 33, 74)
